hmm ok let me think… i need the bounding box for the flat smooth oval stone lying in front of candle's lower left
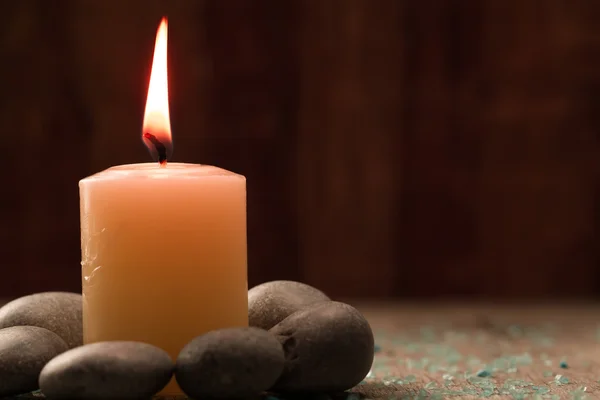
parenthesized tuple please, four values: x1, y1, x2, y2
(40, 341, 174, 400)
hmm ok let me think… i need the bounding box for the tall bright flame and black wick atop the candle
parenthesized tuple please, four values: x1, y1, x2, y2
(142, 17, 173, 166)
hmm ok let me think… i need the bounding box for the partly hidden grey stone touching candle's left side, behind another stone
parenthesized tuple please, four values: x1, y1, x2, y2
(0, 292, 83, 348)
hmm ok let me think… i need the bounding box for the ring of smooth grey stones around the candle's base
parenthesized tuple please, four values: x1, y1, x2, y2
(0, 281, 374, 400)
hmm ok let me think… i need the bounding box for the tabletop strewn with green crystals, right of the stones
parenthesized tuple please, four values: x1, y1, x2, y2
(2, 303, 600, 399)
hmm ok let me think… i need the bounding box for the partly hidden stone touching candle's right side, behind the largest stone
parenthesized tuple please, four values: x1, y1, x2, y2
(248, 281, 330, 329)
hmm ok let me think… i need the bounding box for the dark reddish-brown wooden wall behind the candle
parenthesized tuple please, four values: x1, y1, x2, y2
(0, 0, 600, 298)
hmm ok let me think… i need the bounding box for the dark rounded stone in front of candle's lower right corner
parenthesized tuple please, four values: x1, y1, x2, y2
(175, 328, 285, 399)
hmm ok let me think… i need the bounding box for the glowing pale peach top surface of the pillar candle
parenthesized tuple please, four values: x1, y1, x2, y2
(83, 162, 245, 181)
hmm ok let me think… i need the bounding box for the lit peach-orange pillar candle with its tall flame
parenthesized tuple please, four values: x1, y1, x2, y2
(79, 19, 248, 394)
